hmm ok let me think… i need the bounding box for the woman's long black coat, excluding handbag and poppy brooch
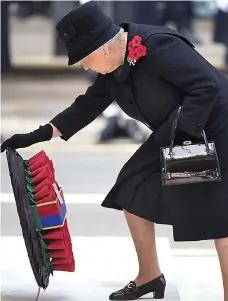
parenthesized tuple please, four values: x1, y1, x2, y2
(51, 24, 228, 241)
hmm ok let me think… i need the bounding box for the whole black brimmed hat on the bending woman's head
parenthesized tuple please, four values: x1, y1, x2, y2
(56, 1, 120, 65)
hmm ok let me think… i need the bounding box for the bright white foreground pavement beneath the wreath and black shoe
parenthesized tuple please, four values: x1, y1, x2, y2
(1, 237, 223, 301)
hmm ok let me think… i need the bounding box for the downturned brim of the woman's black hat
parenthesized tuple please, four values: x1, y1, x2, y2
(68, 24, 120, 66)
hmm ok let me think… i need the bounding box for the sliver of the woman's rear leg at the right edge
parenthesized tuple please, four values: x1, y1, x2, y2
(215, 237, 228, 301)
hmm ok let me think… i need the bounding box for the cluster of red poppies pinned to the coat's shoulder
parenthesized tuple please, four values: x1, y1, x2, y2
(127, 35, 147, 66)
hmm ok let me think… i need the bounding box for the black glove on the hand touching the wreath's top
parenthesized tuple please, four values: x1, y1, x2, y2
(1, 123, 53, 153)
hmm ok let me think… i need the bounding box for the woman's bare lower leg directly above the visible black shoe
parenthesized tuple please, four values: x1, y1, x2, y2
(124, 210, 161, 286)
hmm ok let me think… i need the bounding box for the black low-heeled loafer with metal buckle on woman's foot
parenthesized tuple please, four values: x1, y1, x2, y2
(109, 274, 166, 300)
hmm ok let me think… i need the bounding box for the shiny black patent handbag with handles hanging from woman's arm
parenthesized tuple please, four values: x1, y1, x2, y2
(161, 107, 221, 186)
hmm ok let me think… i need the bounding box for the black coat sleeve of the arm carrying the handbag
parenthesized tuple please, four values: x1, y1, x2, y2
(148, 34, 219, 138)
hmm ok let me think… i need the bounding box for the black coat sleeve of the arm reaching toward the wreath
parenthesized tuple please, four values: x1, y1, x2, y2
(50, 75, 113, 141)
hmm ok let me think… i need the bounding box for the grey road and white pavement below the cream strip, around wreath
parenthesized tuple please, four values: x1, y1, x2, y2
(0, 150, 223, 301)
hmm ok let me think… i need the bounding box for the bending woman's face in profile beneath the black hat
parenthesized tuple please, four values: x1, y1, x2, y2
(82, 48, 117, 74)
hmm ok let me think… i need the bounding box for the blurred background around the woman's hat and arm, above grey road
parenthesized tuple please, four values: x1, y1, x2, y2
(1, 0, 228, 144)
